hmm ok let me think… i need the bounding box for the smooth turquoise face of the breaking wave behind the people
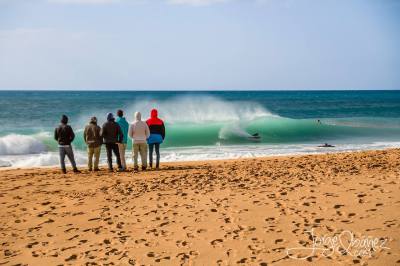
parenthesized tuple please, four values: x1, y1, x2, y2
(30, 117, 400, 150)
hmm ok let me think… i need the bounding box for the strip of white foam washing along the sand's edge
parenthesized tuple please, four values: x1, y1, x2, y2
(0, 142, 400, 168)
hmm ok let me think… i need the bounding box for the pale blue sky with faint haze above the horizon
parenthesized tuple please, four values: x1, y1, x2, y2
(0, 0, 400, 90)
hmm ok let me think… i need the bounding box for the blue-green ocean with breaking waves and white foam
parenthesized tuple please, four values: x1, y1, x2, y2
(0, 91, 400, 167)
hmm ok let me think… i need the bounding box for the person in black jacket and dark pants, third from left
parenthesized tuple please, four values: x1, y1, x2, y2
(101, 113, 124, 172)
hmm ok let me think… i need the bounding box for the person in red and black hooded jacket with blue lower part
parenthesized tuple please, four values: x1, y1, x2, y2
(146, 109, 165, 169)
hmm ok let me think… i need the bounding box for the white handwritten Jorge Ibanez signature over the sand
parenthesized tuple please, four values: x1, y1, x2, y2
(286, 228, 390, 260)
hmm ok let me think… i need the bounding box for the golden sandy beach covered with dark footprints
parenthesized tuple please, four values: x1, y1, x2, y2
(0, 149, 400, 265)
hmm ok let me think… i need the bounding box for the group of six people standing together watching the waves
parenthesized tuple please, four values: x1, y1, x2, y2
(54, 109, 165, 173)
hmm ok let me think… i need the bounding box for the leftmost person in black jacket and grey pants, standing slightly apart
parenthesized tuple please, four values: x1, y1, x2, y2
(54, 115, 79, 174)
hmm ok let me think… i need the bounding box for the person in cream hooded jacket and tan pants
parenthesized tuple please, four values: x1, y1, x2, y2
(128, 112, 150, 171)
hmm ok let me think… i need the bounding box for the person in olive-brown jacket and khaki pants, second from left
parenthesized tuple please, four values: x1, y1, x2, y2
(83, 117, 102, 171)
